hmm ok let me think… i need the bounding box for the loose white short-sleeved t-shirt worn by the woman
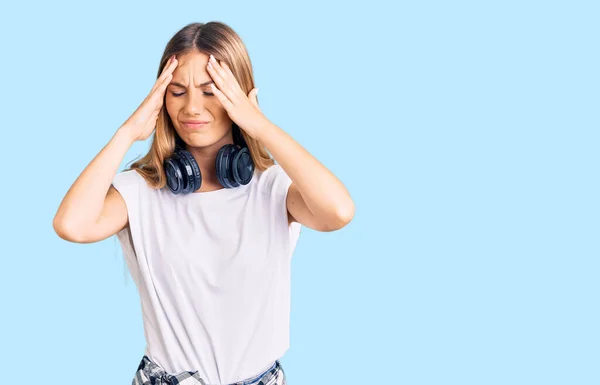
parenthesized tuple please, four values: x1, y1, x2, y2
(113, 164, 301, 384)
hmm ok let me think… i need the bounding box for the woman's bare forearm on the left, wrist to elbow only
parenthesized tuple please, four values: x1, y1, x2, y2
(53, 126, 134, 231)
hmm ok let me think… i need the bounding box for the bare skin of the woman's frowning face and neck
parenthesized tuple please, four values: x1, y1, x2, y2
(165, 52, 233, 193)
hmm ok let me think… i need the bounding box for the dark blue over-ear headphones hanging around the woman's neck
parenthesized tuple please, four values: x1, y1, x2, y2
(163, 123, 254, 194)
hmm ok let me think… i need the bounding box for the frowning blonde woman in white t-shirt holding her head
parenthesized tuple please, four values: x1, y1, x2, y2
(54, 22, 354, 384)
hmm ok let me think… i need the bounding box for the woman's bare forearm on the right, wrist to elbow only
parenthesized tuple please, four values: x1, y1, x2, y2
(258, 120, 354, 220)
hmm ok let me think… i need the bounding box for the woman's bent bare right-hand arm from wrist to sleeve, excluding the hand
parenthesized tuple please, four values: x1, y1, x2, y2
(255, 120, 355, 231)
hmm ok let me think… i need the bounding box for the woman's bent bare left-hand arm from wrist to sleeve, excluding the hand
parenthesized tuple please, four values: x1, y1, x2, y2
(52, 126, 134, 243)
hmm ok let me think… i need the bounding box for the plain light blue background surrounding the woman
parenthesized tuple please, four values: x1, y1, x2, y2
(0, 1, 600, 385)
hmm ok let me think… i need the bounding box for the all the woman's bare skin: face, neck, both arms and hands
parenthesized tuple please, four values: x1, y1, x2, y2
(53, 52, 354, 243)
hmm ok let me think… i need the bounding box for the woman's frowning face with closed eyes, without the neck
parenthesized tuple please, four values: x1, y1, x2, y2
(165, 52, 232, 147)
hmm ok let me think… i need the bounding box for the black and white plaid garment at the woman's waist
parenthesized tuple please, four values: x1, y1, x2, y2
(131, 355, 286, 385)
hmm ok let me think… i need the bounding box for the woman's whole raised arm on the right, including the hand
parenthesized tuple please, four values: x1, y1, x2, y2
(202, 55, 354, 231)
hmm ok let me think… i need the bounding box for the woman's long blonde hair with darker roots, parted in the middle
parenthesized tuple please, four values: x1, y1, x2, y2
(126, 21, 275, 189)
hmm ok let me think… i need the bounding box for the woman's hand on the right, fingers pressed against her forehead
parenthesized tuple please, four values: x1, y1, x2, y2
(207, 55, 267, 139)
